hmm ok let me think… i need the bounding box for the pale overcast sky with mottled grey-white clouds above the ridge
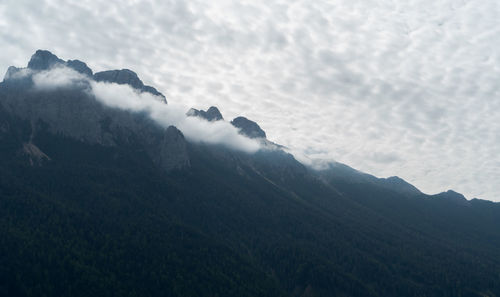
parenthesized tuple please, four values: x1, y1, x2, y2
(0, 0, 500, 201)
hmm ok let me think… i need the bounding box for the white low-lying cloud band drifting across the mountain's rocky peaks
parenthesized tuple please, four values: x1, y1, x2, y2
(31, 66, 260, 153)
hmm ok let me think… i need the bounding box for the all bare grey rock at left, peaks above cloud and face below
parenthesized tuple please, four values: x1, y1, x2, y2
(0, 51, 186, 171)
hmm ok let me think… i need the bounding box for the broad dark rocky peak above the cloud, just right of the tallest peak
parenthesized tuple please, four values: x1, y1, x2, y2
(94, 69, 167, 103)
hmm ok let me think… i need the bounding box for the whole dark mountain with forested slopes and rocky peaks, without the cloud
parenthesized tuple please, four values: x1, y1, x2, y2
(0, 51, 500, 296)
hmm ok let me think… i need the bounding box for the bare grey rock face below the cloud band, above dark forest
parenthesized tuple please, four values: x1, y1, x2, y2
(0, 84, 190, 171)
